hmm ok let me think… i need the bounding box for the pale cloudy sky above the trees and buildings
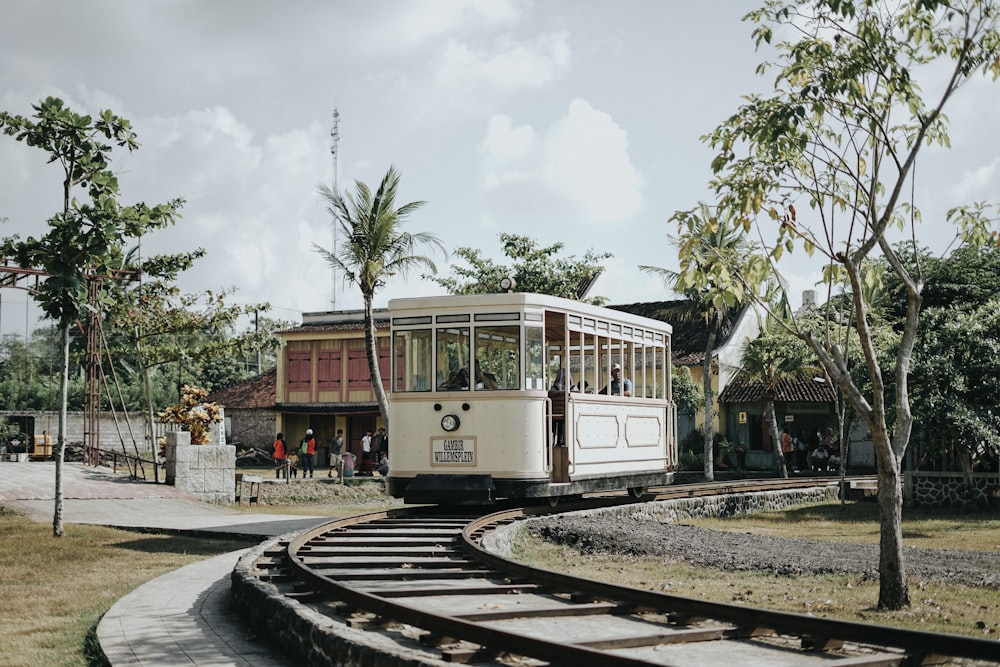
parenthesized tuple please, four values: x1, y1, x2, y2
(0, 0, 1000, 340)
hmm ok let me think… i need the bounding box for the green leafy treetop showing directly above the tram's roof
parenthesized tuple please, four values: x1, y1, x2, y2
(431, 233, 612, 306)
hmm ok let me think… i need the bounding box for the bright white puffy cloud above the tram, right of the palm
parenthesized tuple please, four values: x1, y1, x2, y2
(480, 99, 643, 224)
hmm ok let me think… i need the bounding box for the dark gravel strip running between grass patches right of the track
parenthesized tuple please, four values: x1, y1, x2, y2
(531, 515, 1000, 589)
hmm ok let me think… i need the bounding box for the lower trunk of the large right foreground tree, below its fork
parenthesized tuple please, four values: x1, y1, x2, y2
(875, 435, 910, 610)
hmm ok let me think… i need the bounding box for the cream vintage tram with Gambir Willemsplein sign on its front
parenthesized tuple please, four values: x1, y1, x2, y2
(386, 291, 677, 504)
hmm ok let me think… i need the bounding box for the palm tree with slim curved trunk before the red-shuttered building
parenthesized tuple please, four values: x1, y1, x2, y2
(313, 166, 444, 428)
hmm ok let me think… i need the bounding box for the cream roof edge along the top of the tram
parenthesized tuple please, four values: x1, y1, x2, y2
(389, 292, 673, 334)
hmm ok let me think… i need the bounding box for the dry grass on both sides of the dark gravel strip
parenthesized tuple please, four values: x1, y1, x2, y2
(515, 504, 1000, 638)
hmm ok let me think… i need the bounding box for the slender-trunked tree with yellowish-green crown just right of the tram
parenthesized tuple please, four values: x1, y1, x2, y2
(639, 204, 755, 481)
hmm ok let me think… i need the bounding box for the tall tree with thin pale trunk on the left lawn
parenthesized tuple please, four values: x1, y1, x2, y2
(0, 97, 181, 537)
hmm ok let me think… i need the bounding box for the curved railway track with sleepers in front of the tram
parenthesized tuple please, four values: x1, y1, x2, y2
(242, 481, 1000, 667)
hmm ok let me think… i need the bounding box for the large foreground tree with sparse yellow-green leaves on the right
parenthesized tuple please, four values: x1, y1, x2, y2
(706, 0, 1000, 609)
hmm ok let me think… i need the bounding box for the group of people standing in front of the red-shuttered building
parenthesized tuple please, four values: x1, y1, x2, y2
(272, 428, 389, 479)
